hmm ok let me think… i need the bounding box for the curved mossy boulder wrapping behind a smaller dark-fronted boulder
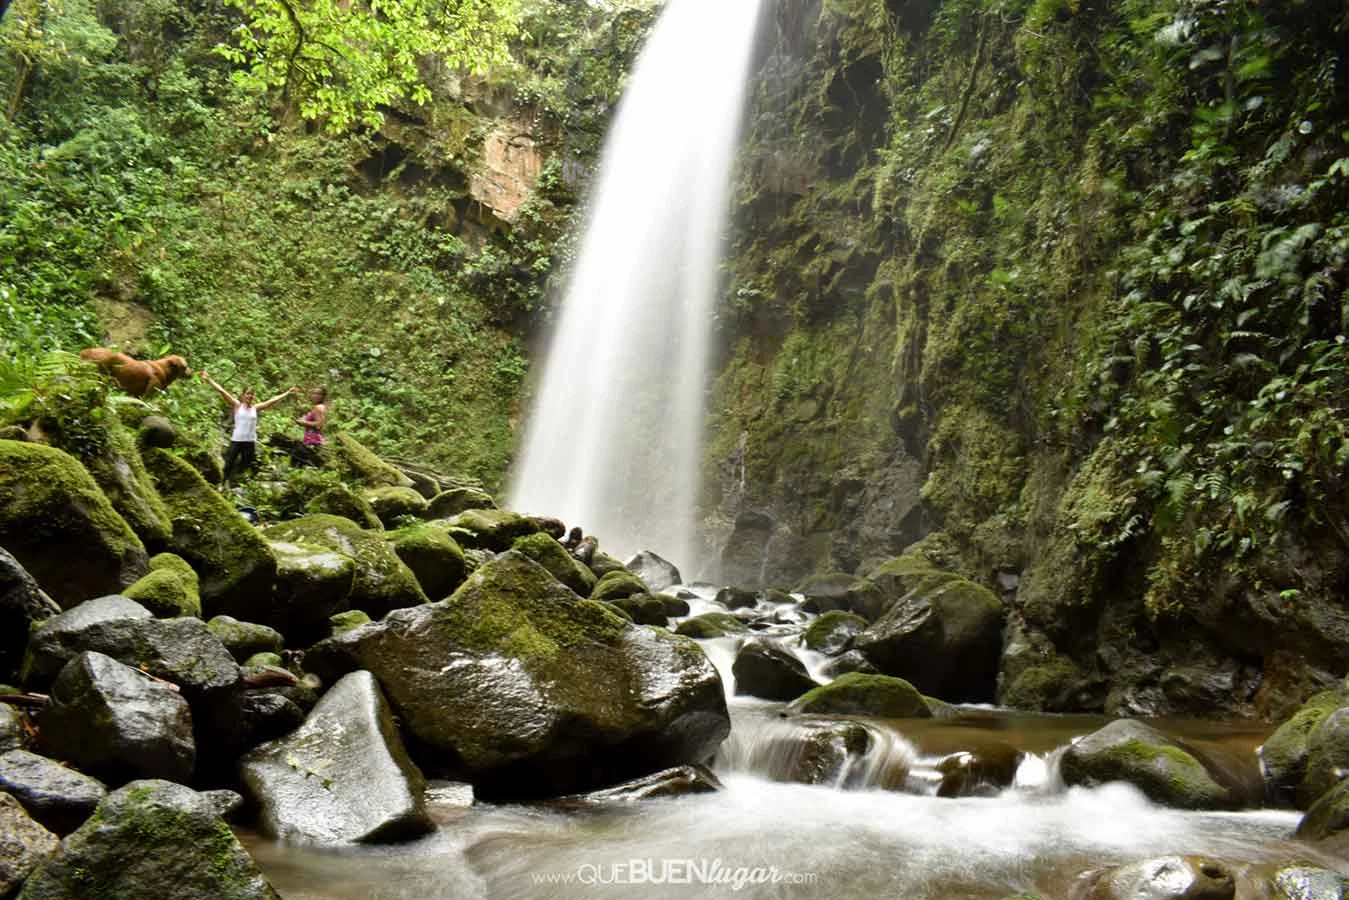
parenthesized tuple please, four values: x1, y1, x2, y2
(266, 515, 426, 618)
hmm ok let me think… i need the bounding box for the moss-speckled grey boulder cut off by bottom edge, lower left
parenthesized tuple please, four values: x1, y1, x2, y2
(19, 781, 279, 900)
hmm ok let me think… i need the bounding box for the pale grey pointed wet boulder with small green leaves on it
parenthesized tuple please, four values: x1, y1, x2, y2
(239, 672, 433, 843)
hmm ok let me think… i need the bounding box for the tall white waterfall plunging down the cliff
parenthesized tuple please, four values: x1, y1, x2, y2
(510, 0, 761, 565)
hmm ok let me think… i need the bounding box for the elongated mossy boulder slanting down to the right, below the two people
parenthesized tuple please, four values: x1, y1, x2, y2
(144, 448, 277, 619)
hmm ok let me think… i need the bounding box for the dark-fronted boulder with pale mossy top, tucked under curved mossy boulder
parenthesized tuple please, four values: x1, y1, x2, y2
(258, 541, 356, 645)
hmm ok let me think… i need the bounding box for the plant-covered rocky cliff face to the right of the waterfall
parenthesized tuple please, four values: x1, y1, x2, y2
(703, 0, 1349, 714)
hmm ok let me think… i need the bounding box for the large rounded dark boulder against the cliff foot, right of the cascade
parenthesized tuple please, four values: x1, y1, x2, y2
(853, 556, 1002, 702)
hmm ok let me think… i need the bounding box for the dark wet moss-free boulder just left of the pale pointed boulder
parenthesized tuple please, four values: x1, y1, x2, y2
(39, 653, 197, 784)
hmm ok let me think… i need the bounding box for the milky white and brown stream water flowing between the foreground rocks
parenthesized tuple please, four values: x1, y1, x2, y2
(246, 594, 1349, 900)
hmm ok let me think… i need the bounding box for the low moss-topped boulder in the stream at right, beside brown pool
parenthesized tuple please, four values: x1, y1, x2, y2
(1060, 719, 1238, 810)
